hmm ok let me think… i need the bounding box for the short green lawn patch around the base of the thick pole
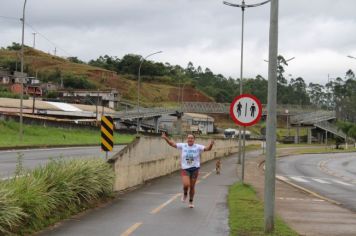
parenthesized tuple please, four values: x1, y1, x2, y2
(228, 183, 298, 236)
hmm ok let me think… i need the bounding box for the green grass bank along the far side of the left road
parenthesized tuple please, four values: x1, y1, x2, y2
(0, 121, 134, 147)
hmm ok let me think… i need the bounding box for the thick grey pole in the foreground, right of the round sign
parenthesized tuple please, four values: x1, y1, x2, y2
(264, 0, 278, 233)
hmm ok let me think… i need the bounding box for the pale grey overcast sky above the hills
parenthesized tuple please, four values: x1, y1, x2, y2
(0, 0, 356, 84)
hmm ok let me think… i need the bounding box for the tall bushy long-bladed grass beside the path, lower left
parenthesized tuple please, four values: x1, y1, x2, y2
(0, 159, 115, 235)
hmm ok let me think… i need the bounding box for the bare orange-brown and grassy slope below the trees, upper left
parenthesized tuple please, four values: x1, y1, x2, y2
(0, 47, 213, 106)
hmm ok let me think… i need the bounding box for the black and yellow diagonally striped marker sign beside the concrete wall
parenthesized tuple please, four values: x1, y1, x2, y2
(101, 116, 114, 157)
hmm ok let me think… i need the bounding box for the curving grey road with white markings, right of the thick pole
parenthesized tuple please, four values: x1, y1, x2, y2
(277, 153, 356, 211)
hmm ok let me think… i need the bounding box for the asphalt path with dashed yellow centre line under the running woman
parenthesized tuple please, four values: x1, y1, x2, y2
(39, 151, 257, 236)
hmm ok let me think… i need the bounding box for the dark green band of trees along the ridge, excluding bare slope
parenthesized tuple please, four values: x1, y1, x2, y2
(88, 54, 356, 122)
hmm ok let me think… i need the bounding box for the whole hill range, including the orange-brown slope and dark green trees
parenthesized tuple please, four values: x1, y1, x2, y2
(0, 44, 356, 120)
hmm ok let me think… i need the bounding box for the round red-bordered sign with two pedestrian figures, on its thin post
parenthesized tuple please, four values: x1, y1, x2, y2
(230, 94, 262, 183)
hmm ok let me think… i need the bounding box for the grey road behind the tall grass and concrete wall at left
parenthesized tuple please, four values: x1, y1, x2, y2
(0, 145, 125, 178)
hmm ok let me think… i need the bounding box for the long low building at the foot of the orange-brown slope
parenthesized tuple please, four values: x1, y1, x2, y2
(58, 89, 120, 109)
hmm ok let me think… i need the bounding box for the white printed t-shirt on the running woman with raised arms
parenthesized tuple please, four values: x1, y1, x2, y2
(177, 143, 205, 169)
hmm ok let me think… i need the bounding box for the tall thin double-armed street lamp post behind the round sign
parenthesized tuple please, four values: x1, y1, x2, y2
(223, 0, 270, 164)
